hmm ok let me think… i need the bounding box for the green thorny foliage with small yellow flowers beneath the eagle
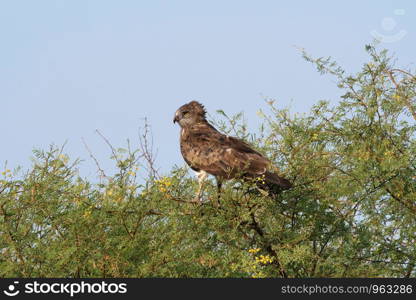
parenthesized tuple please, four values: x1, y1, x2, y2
(0, 46, 416, 277)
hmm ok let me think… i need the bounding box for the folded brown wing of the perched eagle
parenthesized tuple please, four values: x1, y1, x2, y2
(181, 124, 270, 178)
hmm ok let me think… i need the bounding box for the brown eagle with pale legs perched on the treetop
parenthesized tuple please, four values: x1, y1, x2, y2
(173, 101, 292, 203)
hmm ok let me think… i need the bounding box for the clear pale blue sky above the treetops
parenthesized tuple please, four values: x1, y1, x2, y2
(0, 0, 416, 176)
